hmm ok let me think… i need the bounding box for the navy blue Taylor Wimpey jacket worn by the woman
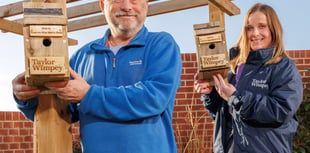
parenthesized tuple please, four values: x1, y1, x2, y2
(202, 48, 303, 153)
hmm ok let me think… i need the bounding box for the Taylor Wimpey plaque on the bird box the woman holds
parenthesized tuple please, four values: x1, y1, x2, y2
(200, 54, 228, 68)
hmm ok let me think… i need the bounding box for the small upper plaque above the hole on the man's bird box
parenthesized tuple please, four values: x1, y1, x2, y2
(29, 25, 63, 37)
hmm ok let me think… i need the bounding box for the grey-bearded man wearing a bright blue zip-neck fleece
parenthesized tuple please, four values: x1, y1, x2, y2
(12, 0, 181, 153)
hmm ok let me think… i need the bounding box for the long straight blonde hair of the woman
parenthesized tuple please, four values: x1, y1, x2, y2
(230, 3, 288, 74)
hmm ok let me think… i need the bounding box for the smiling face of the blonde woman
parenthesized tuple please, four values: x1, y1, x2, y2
(246, 11, 272, 51)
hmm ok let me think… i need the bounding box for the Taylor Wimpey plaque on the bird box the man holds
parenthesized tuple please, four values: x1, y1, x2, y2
(29, 57, 67, 75)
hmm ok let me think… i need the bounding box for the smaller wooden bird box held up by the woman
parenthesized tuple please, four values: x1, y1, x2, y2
(194, 23, 229, 81)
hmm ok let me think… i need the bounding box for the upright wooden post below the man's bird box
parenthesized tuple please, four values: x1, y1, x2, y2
(34, 94, 72, 153)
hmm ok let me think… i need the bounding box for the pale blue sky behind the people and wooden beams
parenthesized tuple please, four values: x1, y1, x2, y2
(0, 0, 310, 111)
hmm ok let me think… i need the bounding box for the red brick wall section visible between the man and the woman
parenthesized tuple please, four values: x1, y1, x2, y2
(173, 53, 213, 153)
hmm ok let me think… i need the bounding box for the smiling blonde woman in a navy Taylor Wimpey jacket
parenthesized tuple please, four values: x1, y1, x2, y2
(195, 3, 303, 153)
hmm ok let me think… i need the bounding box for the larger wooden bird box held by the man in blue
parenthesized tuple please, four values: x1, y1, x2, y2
(23, 2, 70, 86)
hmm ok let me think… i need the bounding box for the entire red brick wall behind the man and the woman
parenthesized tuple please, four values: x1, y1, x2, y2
(0, 50, 310, 153)
